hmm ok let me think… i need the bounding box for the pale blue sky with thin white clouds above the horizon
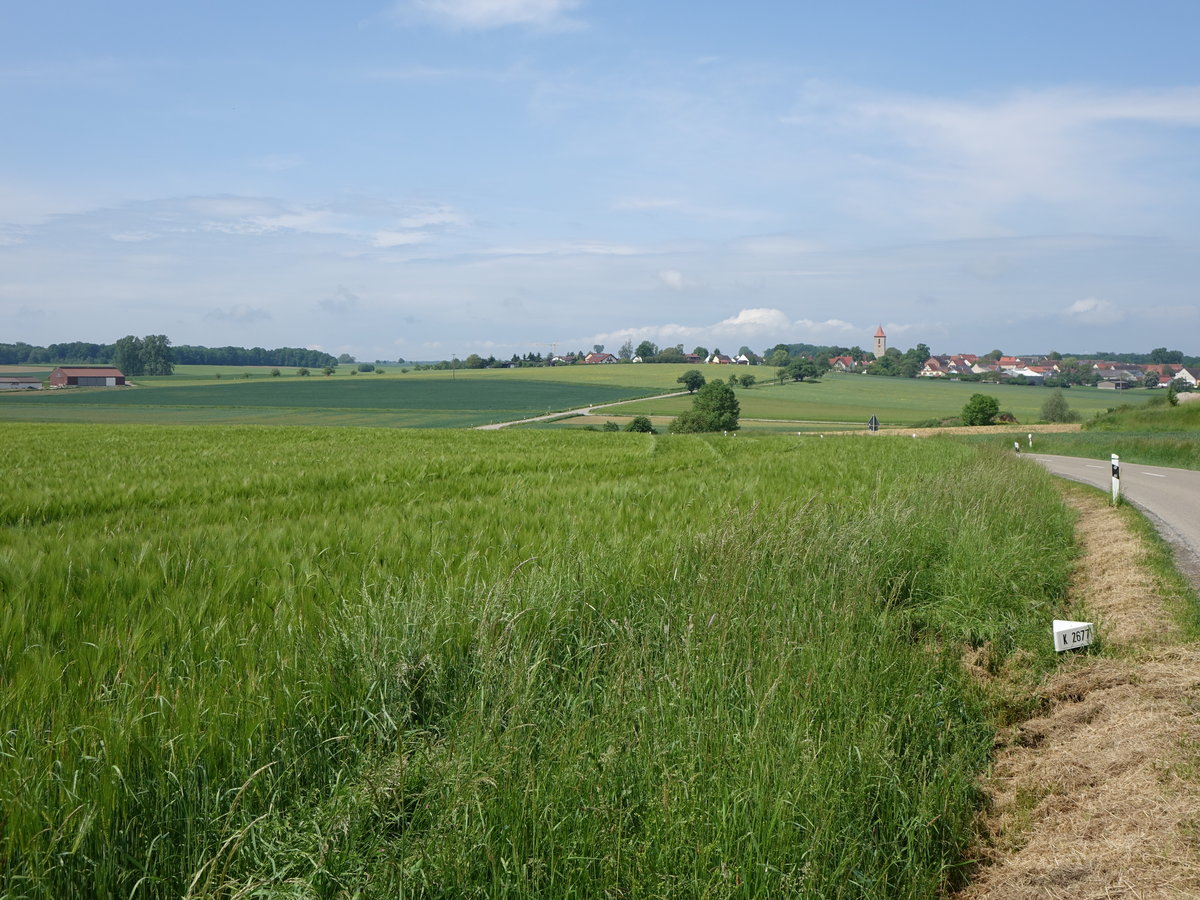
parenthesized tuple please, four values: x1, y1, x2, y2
(0, 0, 1200, 361)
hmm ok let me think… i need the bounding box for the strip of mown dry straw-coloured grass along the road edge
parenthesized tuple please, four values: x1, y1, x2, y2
(959, 490, 1200, 900)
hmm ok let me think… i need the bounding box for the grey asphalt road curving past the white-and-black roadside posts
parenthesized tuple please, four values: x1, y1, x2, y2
(1027, 454, 1200, 589)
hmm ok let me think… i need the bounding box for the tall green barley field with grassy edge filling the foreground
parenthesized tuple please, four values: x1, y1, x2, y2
(0, 427, 1073, 900)
